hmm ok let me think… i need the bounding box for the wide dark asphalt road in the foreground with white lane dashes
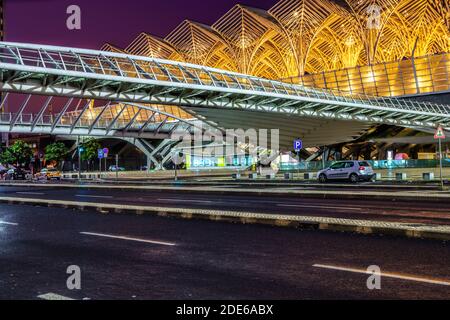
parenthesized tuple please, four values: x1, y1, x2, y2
(0, 205, 450, 300)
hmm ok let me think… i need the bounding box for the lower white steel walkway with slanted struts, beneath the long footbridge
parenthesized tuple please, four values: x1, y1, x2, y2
(0, 93, 201, 139)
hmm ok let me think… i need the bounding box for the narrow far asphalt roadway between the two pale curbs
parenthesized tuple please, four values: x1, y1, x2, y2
(0, 185, 450, 224)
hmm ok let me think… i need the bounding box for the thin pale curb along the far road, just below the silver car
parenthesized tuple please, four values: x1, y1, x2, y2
(0, 183, 450, 203)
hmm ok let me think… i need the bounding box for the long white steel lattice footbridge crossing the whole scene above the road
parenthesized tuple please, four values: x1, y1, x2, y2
(0, 43, 450, 131)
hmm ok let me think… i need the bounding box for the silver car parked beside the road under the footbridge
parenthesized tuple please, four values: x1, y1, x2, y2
(317, 161, 375, 183)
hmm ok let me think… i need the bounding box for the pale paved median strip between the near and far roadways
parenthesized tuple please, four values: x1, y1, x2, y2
(0, 197, 450, 241)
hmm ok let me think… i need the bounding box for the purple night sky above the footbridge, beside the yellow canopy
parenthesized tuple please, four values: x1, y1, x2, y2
(4, 0, 277, 49)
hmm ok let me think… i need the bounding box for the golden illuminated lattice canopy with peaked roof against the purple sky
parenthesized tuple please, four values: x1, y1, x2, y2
(104, 0, 450, 79)
